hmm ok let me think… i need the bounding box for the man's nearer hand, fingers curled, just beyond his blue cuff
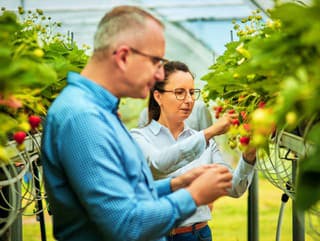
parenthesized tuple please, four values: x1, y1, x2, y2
(186, 164, 232, 206)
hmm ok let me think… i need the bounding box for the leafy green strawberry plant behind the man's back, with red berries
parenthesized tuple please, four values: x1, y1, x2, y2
(0, 7, 88, 164)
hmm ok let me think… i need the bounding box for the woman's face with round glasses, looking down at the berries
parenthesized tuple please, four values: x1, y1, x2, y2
(156, 71, 194, 122)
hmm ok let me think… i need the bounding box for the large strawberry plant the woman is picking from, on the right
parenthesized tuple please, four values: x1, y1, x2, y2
(202, 0, 320, 210)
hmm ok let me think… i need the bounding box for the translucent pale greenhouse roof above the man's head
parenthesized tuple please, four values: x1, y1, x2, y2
(0, 0, 307, 78)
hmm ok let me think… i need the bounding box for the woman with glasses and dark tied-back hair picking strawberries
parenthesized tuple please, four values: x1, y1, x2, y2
(131, 61, 255, 241)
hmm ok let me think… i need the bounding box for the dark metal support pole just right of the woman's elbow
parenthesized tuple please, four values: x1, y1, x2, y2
(248, 170, 259, 241)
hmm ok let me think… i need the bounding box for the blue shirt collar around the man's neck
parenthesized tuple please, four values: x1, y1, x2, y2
(67, 72, 120, 113)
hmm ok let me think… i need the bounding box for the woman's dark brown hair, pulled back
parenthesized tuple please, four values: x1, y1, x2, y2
(147, 61, 194, 124)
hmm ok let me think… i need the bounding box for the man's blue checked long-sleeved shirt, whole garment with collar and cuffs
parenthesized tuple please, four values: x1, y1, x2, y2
(41, 72, 196, 241)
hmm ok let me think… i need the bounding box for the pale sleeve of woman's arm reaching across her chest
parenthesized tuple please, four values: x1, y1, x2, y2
(131, 129, 206, 178)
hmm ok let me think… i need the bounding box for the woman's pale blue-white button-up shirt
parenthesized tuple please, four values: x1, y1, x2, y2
(131, 120, 254, 226)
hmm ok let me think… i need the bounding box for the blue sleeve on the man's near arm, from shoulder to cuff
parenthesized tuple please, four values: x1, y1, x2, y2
(59, 113, 196, 241)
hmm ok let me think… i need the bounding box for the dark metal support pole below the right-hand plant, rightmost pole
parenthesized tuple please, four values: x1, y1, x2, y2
(292, 161, 305, 241)
